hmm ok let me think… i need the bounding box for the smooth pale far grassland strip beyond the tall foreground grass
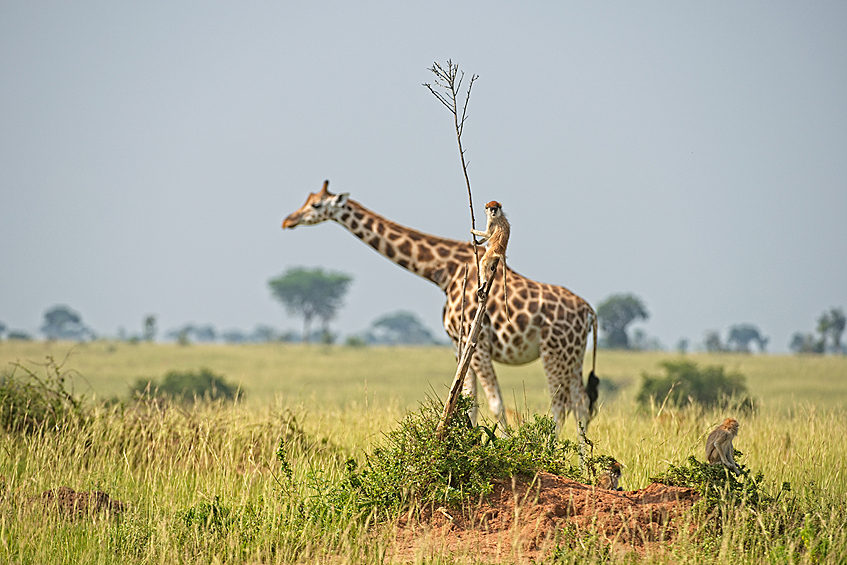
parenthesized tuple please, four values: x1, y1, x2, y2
(0, 341, 847, 412)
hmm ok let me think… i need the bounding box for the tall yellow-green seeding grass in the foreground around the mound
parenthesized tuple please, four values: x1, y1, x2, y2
(0, 350, 847, 564)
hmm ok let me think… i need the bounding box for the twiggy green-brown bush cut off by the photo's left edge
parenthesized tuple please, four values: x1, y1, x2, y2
(0, 357, 83, 433)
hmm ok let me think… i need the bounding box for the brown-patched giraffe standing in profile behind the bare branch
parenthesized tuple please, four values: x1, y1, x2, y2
(282, 181, 599, 433)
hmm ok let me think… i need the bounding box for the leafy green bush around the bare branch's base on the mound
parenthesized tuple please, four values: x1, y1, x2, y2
(314, 397, 609, 511)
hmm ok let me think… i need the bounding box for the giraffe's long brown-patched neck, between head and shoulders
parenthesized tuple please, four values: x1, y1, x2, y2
(335, 200, 473, 292)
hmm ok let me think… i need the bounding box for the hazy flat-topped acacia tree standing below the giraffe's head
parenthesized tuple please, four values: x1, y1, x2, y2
(268, 267, 353, 342)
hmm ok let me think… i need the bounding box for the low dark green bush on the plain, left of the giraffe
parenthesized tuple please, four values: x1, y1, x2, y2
(132, 369, 243, 402)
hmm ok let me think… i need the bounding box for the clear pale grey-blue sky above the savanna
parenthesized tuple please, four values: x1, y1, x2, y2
(0, 0, 847, 352)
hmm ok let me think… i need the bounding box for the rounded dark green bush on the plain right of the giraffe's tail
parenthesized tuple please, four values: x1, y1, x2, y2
(637, 360, 754, 409)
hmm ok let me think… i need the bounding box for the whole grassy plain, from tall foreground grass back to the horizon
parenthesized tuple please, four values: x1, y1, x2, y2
(0, 342, 847, 564)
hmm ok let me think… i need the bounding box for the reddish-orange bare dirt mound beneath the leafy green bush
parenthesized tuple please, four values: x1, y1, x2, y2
(393, 473, 700, 561)
